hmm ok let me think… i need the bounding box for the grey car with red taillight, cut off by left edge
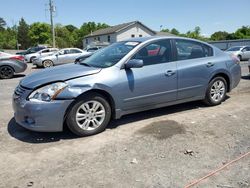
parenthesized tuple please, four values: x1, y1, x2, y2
(0, 52, 27, 79)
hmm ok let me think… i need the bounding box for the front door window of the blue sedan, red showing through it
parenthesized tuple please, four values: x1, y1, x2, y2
(133, 40, 172, 66)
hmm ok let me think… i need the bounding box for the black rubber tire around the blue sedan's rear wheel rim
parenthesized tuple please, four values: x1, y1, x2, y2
(204, 76, 227, 106)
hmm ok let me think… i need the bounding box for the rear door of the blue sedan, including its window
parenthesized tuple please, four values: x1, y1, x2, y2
(174, 39, 216, 99)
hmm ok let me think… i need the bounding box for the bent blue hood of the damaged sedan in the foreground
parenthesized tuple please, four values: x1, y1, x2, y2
(20, 64, 101, 89)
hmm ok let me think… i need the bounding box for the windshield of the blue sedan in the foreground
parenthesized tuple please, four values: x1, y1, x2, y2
(80, 42, 139, 68)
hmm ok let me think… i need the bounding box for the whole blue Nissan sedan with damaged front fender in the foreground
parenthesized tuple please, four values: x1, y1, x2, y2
(13, 37, 241, 136)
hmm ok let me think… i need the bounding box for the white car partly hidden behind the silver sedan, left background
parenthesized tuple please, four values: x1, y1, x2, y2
(24, 48, 58, 63)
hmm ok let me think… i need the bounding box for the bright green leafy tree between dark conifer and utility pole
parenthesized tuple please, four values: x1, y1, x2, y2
(28, 22, 52, 45)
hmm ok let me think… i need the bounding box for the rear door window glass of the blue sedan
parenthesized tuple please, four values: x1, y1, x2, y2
(175, 39, 213, 60)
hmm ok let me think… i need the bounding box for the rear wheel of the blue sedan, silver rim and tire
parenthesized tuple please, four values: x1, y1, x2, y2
(204, 77, 227, 106)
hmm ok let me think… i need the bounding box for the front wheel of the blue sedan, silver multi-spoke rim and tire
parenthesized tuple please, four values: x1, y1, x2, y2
(66, 93, 111, 136)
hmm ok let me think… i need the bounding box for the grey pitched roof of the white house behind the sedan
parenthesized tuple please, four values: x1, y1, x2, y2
(84, 21, 156, 38)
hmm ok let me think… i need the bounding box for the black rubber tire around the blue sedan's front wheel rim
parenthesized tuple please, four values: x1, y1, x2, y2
(66, 92, 111, 136)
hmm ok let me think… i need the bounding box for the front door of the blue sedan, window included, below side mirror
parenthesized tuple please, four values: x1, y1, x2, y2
(116, 39, 177, 111)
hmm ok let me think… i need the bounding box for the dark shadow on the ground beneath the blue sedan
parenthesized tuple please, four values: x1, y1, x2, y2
(8, 96, 230, 144)
